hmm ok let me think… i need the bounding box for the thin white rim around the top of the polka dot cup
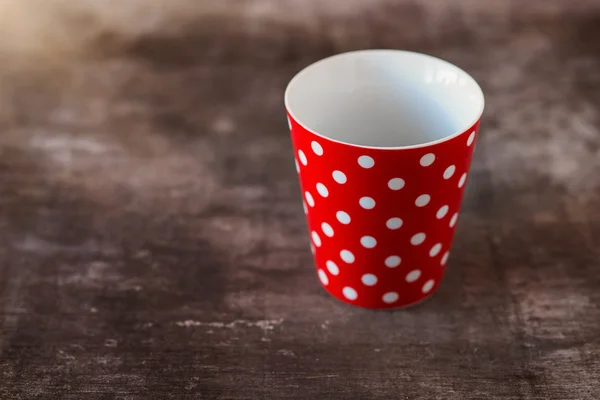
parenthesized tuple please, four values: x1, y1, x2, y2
(284, 49, 485, 150)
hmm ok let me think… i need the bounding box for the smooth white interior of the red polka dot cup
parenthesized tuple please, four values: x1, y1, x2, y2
(285, 50, 484, 148)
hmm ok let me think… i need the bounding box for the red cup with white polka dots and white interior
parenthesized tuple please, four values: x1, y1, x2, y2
(285, 50, 484, 309)
